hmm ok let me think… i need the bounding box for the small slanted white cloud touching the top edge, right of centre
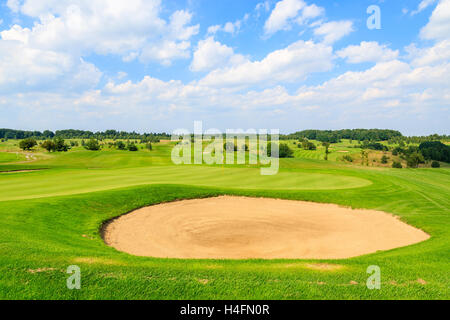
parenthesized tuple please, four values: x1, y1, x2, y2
(264, 0, 306, 35)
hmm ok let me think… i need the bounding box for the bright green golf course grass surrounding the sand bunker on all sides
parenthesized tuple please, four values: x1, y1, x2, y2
(0, 144, 450, 299)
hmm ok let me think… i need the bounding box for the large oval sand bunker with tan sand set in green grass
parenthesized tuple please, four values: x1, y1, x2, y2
(103, 196, 429, 259)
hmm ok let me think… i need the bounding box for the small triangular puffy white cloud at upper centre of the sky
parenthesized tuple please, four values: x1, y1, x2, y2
(190, 37, 246, 71)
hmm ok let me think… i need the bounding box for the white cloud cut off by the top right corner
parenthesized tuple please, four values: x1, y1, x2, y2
(420, 0, 450, 40)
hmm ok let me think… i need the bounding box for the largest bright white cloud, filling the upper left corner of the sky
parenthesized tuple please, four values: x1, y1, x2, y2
(2, 0, 199, 64)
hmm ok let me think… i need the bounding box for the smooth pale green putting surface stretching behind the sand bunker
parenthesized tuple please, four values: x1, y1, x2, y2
(0, 166, 371, 201)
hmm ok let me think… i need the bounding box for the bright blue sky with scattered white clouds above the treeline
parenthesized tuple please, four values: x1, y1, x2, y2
(0, 0, 450, 135)
